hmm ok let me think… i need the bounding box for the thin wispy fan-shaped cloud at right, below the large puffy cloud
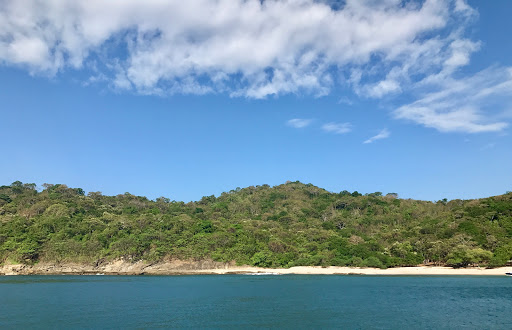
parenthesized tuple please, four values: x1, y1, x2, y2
(393, 68, 512, 133)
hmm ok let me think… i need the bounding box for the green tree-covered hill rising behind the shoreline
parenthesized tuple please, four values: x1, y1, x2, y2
(0, 181, 512, 267)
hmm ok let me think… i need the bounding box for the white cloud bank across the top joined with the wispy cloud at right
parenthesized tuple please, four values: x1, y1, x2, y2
(0, 0, 512, 132)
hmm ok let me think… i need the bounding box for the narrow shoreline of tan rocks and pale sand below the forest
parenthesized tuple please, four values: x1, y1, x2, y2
(0, 260, 512, 276)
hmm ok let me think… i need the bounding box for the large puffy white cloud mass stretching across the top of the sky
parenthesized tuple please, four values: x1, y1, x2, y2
(0, 0, 454, 98)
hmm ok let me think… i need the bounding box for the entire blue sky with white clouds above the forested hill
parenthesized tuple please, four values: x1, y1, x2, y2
(0, 0, 512, 202)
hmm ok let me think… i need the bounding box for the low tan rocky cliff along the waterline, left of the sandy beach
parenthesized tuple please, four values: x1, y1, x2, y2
(0, 260, 235, 275)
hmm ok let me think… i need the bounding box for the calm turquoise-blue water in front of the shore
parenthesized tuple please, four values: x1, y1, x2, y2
(0, 275, 512, 329)
